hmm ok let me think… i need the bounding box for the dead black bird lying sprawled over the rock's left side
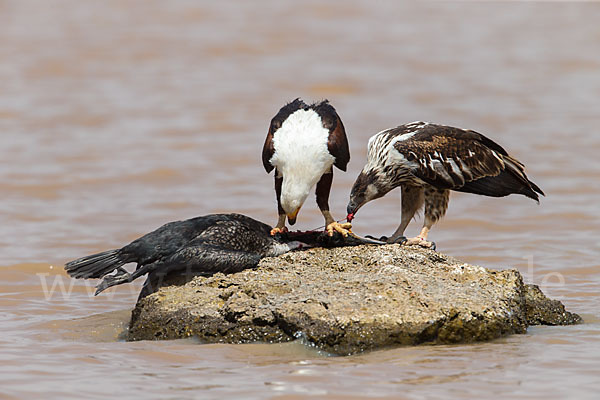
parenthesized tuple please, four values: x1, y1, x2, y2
(65, 214, 303, 298)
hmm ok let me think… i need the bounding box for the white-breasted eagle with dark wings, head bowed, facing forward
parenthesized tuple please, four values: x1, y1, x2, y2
(262, 99, 351, 236)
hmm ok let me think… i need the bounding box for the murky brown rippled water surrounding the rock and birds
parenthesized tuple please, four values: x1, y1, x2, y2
(0, 0, 600, 399)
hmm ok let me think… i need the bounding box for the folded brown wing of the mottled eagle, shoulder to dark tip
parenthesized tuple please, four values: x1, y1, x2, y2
(394, 124, 543, 200)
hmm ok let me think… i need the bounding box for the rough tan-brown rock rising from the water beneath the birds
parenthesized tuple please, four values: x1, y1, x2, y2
(128, 245, 581, 354)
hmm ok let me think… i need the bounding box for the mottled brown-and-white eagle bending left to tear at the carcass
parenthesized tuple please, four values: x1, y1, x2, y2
(347, 122, 544, 247)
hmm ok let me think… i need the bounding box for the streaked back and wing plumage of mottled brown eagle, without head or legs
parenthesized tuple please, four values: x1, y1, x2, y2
(363, 122, 543, 201)
